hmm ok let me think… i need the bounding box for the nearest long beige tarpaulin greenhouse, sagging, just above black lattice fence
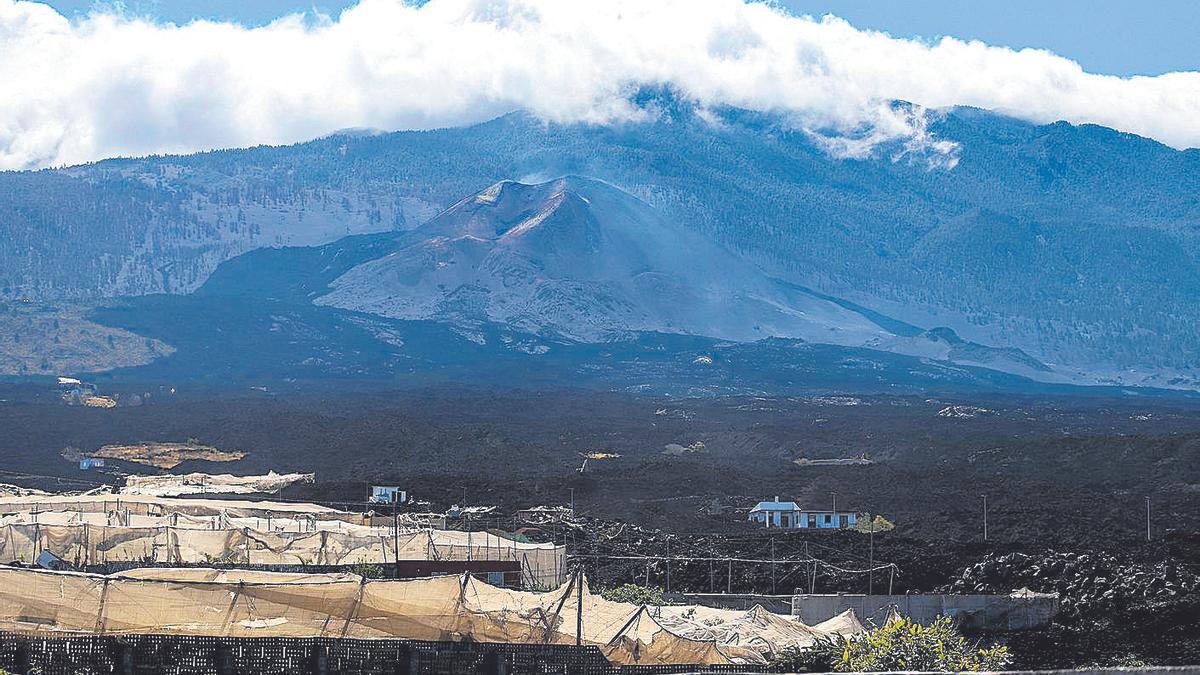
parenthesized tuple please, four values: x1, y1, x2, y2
(0, 568, 763, 665)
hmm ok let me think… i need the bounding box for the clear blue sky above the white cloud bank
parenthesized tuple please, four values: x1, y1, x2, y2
(49, 0, 1200, 76)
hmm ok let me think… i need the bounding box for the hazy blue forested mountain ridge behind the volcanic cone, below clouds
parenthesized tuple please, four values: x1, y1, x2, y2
(0, 107, 1200, 387)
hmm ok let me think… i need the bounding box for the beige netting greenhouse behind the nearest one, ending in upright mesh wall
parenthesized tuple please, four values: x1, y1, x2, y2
(0, 512, 566, 589)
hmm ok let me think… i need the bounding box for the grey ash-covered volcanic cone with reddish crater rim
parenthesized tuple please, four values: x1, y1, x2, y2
(316, 177, 1058, 380)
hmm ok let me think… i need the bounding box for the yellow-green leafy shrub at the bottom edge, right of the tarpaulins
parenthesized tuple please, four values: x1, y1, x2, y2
(772, 616, 1012, 673)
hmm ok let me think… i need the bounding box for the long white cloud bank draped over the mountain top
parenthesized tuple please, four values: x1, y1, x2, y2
(0, 0, 1200, 168)
